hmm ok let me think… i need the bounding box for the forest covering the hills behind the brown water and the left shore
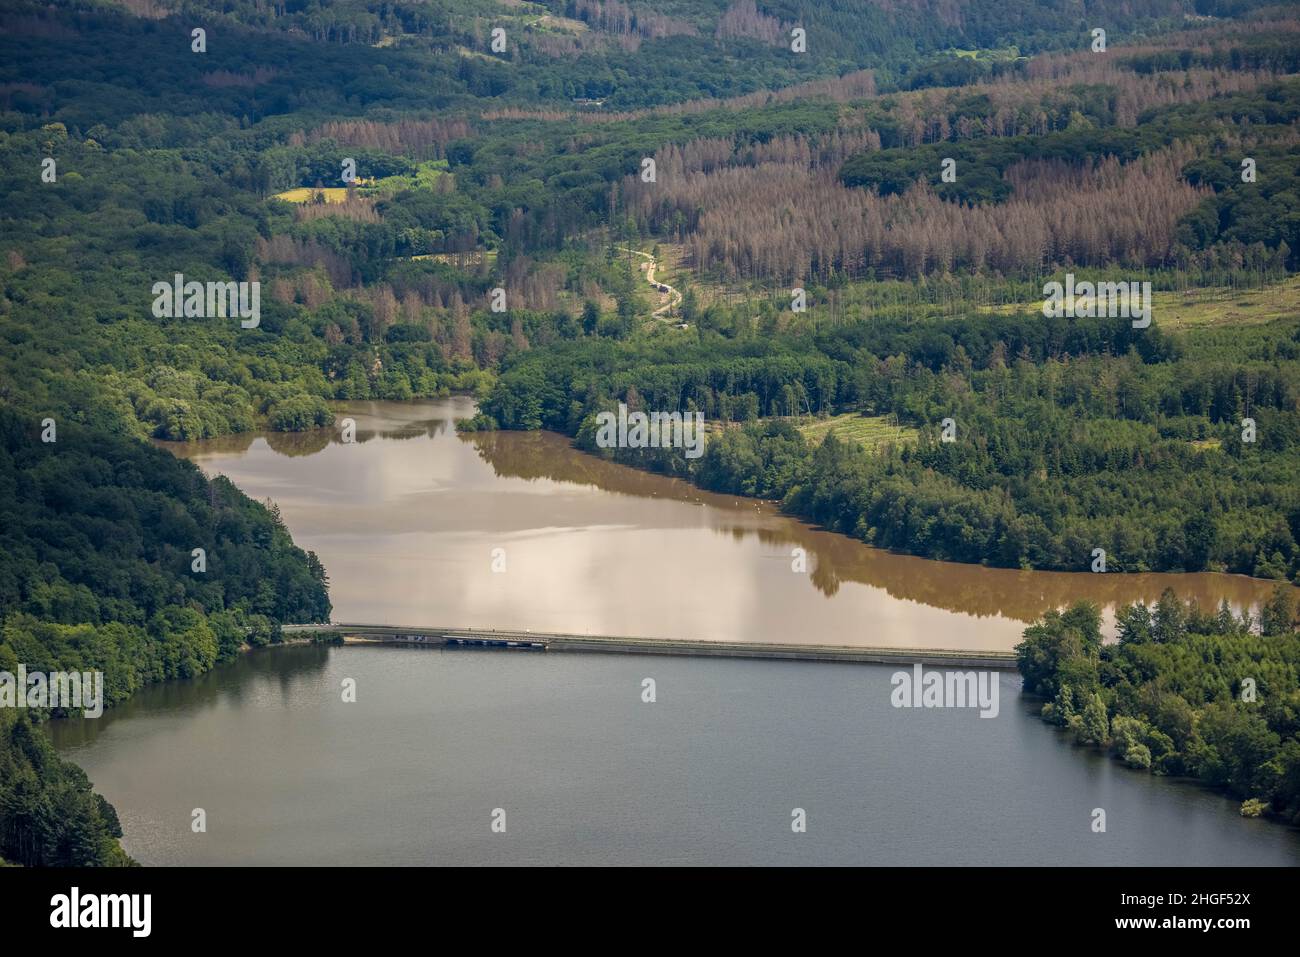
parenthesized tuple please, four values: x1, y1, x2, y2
(0, 0, 1300, 865)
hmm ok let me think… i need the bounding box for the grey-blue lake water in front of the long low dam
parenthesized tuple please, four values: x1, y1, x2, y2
(55, 646, 1300, 865)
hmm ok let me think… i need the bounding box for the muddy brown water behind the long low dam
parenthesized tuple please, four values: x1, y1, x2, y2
(157, 399, 1273, 649)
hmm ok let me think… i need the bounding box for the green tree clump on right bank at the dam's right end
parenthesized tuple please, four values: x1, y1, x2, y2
(1017, 589, 1300, 824)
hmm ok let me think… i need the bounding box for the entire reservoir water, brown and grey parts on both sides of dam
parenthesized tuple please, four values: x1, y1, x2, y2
(52, 399, 1300, 865)
